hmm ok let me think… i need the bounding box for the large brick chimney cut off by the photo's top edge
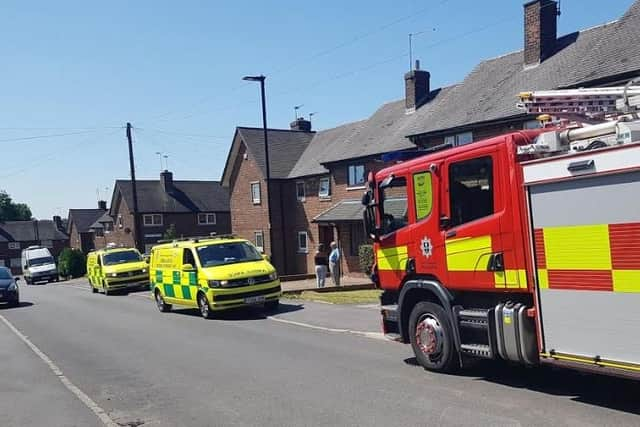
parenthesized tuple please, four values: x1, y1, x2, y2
(524, 0, 558, 67)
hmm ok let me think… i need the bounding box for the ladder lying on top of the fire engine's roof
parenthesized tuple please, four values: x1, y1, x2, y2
(517, 83, 640, 119)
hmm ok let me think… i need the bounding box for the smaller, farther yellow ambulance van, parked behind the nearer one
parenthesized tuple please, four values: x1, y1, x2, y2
(87, 248, 149, 295)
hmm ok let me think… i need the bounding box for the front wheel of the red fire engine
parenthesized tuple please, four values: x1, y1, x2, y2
(409, 302, 459, 372)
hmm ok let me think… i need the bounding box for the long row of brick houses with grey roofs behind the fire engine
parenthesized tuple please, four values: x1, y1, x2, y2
(223, 0, 640, 275)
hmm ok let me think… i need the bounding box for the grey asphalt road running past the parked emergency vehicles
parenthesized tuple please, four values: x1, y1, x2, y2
(0, 283, 640, 427)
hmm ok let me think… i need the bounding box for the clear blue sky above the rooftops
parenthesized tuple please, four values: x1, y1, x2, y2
(0, 0, 633, 218)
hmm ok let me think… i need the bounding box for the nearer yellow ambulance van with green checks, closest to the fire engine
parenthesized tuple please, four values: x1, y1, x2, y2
(149, 236, 281, 318)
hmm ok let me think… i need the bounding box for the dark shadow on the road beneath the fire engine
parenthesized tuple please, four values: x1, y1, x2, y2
(404, 357, 640, 415)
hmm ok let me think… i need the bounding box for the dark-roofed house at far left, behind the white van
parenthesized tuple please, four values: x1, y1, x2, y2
(0, 217, 69, 274)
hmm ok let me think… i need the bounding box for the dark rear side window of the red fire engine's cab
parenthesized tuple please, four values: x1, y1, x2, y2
(449, 156, 494, 227)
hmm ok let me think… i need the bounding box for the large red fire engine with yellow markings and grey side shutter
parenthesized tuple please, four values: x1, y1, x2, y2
(363, 84, 640, 375)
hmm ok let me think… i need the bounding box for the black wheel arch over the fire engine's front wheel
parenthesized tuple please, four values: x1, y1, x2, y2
(398, 278, 460, 348)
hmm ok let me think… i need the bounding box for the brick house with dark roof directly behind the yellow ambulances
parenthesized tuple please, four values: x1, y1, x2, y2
(106, 170, 231, 252)
